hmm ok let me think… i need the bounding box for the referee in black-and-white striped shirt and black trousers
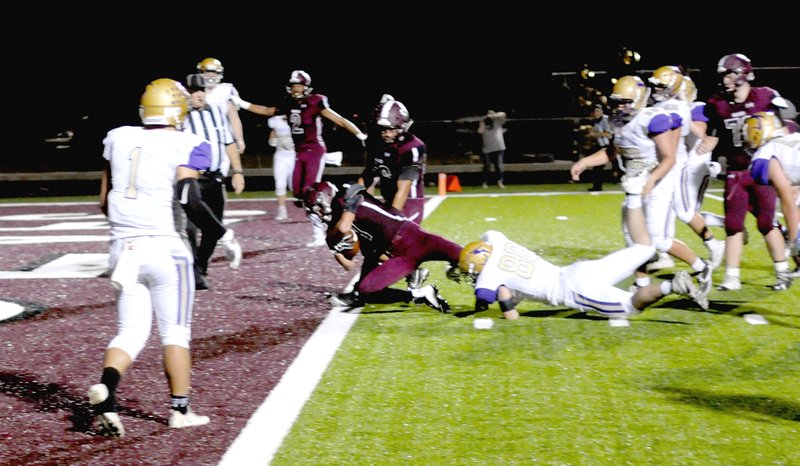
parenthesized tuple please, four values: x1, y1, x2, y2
(183, 74, 244, 290)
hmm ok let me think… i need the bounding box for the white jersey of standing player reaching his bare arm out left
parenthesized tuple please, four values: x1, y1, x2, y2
(614, 107, 672, 174)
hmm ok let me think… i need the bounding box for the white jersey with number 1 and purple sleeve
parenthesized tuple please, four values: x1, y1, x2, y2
(103, 126, 211, 240)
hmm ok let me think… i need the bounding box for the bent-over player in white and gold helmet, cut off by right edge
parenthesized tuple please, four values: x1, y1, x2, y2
(742, 112, 800, 289)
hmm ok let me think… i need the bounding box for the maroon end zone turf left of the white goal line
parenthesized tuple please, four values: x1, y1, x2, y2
(0, 200, 350, 465)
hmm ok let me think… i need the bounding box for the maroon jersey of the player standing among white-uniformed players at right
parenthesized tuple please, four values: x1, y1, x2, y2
(705, 87, 780, 171)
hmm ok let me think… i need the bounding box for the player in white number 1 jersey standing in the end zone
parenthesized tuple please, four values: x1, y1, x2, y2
(88, 78, 211, 437)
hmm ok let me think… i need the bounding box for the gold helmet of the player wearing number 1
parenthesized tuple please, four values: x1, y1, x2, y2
(139, 78, 189, 129)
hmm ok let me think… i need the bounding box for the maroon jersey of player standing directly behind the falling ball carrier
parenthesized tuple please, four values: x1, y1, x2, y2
(361, 133, 428, 209)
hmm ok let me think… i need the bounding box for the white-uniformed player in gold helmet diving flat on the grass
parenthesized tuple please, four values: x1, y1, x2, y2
(458, 184, 708, 320)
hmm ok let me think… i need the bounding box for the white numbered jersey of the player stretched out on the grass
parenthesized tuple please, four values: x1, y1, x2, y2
(475, 230, 564, 306)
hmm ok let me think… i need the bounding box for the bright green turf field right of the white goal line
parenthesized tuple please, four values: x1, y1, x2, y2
(272, 186, 800, 465)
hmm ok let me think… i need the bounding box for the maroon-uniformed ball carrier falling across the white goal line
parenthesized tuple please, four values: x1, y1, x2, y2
(303, 181, 461, 312)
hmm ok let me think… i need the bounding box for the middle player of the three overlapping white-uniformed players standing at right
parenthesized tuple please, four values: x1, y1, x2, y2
(647, 65, 725, 270)
